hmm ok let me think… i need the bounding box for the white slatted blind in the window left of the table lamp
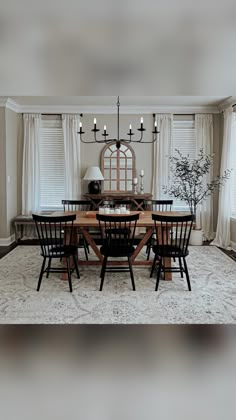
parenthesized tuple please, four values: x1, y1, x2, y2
(40, 119, 65, 210)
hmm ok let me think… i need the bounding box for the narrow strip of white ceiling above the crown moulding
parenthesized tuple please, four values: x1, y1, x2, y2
(11, 96, 229, 107)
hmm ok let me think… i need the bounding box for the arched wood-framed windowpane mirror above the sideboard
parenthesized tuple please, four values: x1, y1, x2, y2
(101, 143, 135, 192)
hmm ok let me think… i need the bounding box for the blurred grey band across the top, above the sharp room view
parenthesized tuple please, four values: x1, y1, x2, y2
(0, 0, 236, 95)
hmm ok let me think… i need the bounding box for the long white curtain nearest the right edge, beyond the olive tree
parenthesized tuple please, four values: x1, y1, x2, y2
(211, 108, 234, 249)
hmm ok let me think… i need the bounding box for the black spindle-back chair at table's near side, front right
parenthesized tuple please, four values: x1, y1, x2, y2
(150, 214, 194, 292)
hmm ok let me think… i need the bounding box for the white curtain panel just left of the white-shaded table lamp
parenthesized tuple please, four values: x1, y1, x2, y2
(62, 114, 81, 200)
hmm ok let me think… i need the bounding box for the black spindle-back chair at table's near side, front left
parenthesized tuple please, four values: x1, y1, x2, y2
(32, 214, 80, 293)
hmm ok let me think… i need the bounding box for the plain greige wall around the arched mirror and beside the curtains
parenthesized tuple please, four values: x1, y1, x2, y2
(0, 108, 223, 242)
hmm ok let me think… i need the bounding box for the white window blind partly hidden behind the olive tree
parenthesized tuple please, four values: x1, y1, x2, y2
(171, 115, 196, 211)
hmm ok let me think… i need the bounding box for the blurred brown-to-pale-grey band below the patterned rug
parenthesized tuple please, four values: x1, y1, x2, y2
(0, 326, 236, 420)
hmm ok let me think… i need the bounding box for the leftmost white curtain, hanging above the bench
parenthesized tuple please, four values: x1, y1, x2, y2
(22, 114, 41, 215)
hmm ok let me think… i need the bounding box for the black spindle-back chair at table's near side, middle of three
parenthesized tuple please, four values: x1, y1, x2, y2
(96, 214, 139, 291)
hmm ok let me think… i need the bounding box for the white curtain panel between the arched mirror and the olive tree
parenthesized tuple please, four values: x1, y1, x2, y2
(152, 114, 173, 200)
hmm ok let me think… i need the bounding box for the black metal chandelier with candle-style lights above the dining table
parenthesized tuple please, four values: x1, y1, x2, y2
(78, 96, 160, 149)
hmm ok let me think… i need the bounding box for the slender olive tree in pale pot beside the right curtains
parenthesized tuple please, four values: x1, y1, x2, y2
(163, 150, 231, 245)
